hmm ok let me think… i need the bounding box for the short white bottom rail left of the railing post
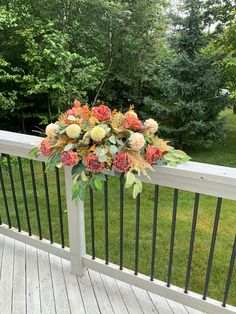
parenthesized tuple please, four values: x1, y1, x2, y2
(0, 224, 70, 261)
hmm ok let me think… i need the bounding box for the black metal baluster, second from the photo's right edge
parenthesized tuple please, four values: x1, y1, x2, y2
(203, 197, 222, 300)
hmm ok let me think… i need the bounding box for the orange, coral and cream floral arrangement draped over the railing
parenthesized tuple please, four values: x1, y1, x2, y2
(31, 100, 190, 200)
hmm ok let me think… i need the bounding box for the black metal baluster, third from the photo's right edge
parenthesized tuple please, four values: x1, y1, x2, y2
(184, 193, 200, 293)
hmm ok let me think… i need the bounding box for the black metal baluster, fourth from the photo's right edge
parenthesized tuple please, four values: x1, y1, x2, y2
(167, 189, 179, 287)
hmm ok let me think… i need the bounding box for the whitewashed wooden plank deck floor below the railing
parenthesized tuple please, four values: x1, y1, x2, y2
(0, 235, 204, 314)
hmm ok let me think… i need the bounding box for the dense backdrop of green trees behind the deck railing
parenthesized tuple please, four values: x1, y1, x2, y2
(0, 0, 236, 147)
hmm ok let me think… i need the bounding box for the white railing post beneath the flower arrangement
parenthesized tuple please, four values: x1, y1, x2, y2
(65, 167, 86, 276)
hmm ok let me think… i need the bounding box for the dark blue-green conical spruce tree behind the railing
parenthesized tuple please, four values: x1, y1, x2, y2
(146, 0, 226, 147)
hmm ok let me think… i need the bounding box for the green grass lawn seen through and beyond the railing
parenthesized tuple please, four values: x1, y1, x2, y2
(0, 111, 236, 305)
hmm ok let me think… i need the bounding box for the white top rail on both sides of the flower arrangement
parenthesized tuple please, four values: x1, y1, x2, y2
(0, 131, 236, 201)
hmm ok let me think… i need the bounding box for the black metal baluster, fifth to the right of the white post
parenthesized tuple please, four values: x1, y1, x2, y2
(150, 185, 159, 281)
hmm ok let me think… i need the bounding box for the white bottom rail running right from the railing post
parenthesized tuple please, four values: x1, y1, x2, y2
(83, 255, 236, 314)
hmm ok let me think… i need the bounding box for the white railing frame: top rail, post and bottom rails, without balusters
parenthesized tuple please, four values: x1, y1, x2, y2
(0, 131, 236, 313)
